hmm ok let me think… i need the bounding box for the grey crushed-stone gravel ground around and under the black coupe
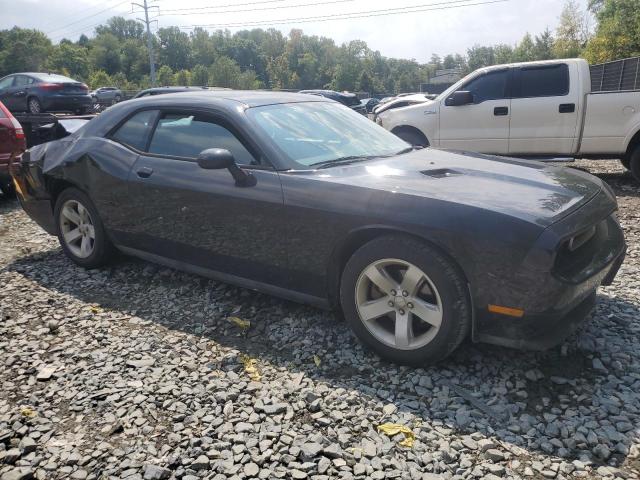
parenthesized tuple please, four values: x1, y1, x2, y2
(0, 162, 640, 480)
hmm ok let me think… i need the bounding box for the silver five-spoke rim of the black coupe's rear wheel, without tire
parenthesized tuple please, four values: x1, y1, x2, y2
(60, 200, 96, 258)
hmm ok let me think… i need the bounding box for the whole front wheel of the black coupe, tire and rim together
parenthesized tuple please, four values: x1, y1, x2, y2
(340, 235, 471, 366)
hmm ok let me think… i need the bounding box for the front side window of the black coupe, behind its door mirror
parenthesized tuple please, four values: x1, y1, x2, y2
(149, 113, 258, 165)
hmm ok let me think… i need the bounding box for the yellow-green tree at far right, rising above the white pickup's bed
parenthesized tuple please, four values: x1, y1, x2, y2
(585, 0, 640, 63)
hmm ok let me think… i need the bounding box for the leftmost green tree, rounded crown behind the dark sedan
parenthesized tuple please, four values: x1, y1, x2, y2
(0, 27, 52, 76)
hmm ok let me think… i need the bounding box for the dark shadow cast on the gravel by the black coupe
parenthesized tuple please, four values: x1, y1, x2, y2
(4, 248, 640, 468)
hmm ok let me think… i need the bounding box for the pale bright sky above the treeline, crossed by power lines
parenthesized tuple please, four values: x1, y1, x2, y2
(0, 0, 587, 62)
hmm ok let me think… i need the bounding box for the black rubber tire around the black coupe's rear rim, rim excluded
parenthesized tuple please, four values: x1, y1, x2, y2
(54, 187, 115, 269)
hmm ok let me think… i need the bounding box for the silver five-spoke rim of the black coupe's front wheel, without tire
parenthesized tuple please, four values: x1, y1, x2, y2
(355, 258, 442, 350)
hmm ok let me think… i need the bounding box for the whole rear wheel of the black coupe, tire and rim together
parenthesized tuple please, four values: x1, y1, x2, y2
(54, 188, 115, 268)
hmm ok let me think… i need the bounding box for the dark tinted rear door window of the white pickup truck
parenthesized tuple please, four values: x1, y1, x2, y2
(513, 63, 569, 98)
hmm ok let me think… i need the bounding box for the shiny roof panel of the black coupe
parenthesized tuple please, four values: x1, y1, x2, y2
(130, 90, 331, 108)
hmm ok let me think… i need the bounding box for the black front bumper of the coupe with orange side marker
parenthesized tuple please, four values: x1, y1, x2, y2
(472, 188, 626, 350)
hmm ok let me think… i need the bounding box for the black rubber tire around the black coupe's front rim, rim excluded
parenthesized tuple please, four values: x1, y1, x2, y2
(340, 235, 471, 366)
